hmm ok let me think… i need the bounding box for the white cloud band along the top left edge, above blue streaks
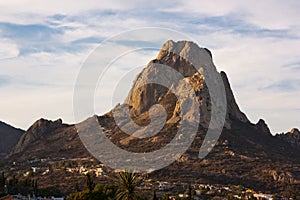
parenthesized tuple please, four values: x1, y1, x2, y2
(0, 0, 130, 24)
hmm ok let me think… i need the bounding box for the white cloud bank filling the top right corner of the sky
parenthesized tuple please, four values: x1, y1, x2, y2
(161, 0, 300, 29)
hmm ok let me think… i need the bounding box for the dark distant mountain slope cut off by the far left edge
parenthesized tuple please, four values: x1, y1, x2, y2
(0, 121, 24, 159)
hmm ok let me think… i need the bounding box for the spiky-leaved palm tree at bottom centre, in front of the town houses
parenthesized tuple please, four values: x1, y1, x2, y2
(116, 171, 142, 200)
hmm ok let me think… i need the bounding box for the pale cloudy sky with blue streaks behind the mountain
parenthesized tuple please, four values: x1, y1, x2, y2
(0, 0, 300, 133)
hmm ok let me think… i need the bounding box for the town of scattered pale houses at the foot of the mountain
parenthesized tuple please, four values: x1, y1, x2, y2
(0, 158, 292, 200)
